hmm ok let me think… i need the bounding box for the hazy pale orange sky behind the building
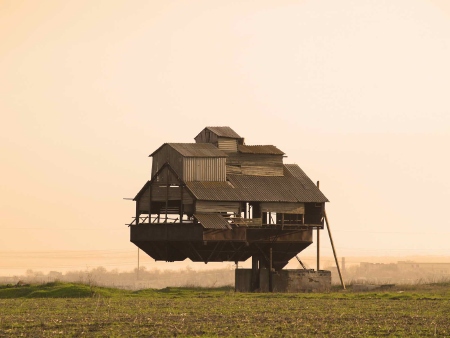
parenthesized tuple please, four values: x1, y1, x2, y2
(0, 0, 450, 274)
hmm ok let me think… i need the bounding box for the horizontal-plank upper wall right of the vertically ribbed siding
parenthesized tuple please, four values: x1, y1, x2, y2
(227, 153, 283, 176)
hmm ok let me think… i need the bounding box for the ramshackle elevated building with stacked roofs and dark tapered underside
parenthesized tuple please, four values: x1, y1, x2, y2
(130, 127, 328, 289)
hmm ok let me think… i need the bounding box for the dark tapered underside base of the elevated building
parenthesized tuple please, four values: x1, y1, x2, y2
(130, 223, 312, 270)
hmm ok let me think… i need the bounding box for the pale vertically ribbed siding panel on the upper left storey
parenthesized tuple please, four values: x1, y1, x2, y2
(183, 157, 226, 182)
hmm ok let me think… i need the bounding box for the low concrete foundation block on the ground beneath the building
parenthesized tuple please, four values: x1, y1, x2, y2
(235, 268, 331, 292)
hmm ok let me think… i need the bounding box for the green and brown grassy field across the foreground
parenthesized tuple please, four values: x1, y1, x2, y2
(0, 283, 450, 337)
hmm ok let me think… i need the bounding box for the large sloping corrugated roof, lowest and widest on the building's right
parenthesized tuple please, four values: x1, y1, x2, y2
(186, 164, 328, 203)
